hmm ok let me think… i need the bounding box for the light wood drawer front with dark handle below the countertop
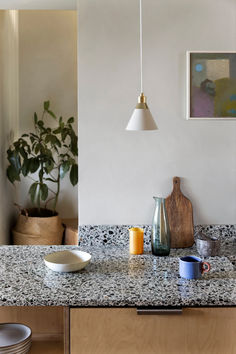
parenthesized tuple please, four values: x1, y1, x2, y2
(70, 308, 236, 354)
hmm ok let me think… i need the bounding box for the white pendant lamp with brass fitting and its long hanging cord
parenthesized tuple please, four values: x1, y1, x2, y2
(126, 0, 158, 130)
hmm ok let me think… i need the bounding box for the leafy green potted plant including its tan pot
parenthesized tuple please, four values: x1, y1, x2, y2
(7, 101, 78, 245)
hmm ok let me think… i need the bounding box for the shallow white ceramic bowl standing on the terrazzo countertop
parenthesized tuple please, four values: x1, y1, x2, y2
(44, 250, 91, 272)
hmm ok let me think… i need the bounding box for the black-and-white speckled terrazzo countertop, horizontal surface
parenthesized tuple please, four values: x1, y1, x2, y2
(0, 227, 236, 307)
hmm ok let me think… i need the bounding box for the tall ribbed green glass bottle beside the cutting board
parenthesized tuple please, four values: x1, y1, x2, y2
(151, 197, 170, 256)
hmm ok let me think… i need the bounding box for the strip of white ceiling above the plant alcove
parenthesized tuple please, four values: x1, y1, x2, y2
(0, 0, 77, 10)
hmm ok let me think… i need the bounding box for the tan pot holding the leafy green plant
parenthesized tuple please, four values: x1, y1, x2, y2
(12, 209, 64, 245)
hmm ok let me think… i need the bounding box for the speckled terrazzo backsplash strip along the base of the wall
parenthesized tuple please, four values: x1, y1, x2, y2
(79, 225, 236, 248)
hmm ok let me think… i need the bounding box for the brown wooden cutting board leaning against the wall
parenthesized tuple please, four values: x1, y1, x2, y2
(166, 177, 194, 248)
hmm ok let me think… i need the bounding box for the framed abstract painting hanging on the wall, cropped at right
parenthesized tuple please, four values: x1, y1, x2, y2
(187, 52, 236, 120)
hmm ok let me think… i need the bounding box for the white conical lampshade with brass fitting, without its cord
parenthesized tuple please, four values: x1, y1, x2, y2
(126, 93, 158, 131)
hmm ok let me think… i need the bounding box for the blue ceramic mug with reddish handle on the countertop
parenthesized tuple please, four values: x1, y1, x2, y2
(179, 256, 211, 279)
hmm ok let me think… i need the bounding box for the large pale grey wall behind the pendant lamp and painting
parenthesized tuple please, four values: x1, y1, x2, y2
(78, 0, 236, 224)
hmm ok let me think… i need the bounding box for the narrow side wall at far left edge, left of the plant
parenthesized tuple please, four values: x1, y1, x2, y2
(0, 11, 18, 244)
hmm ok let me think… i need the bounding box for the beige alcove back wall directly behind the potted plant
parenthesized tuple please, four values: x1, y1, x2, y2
(19, 10, 78, 218)
